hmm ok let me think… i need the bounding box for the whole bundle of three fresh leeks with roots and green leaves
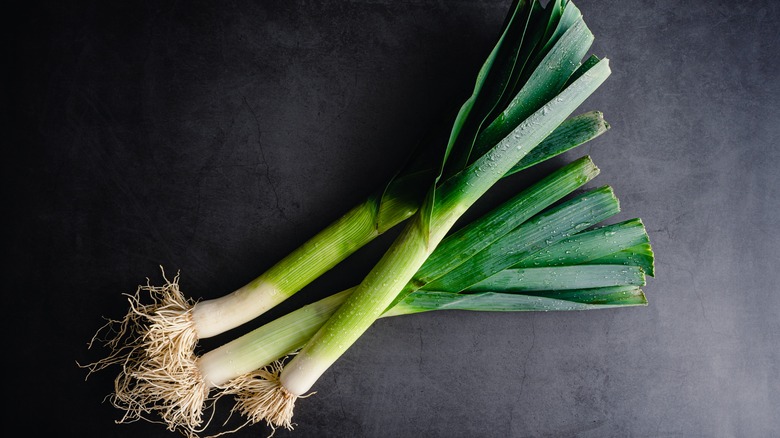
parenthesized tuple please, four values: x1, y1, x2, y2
(82, 0, 653, 435)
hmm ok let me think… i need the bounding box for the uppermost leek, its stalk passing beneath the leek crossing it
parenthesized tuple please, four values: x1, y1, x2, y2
(82, 1, 609, 422)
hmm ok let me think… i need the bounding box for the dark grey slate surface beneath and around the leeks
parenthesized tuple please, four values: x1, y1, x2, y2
(7, 0, 780, 437)
